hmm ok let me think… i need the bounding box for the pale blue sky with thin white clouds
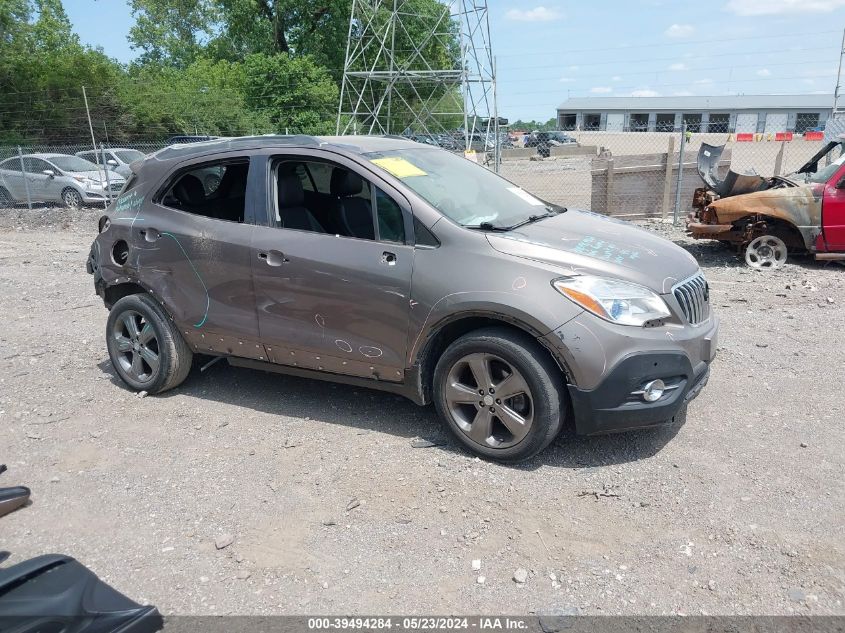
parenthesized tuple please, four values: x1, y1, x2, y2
(64, 0, 845, 120)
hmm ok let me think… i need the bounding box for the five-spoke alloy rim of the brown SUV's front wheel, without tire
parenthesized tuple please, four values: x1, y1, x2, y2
(444, 352, 534, 448)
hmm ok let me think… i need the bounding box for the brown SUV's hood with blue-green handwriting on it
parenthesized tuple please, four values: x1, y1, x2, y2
(487, 209, 699, 293)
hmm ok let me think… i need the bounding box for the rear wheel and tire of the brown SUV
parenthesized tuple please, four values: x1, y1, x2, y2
(106, 294, 193, 394)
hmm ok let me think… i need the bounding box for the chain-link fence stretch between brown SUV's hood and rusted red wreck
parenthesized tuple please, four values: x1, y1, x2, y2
(499, 129, 824, 219)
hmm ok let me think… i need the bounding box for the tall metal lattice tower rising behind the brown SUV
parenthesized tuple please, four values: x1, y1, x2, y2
(337, 0, 498, 150)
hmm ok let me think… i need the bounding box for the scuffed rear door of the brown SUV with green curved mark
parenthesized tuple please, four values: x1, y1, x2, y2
(127, 154, 264, 358)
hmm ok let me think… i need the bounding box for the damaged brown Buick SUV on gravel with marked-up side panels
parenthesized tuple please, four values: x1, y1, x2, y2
(88, 136, 718, 461)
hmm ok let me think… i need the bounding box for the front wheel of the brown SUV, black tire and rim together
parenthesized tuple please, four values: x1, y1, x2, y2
(433, 327, 566, 462)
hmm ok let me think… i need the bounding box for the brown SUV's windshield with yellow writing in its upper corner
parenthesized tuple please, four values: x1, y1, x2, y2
(366, 147, 560, 228)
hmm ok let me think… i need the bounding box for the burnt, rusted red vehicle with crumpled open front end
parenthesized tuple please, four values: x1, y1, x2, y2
(687, 138, 845, 269)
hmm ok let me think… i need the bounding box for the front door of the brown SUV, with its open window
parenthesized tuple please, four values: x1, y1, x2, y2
(252, 156, 414, 381)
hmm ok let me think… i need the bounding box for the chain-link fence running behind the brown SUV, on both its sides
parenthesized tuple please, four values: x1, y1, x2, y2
(0, 128, 824, 219)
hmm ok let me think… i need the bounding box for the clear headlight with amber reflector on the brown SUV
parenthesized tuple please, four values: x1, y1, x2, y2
(552, 275, 671, 326)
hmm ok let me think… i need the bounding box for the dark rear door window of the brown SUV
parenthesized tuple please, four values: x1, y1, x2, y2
(160, 158, 249, 223)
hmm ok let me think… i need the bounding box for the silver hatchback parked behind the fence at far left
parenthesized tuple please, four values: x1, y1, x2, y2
(0, 154, 126, 209)
